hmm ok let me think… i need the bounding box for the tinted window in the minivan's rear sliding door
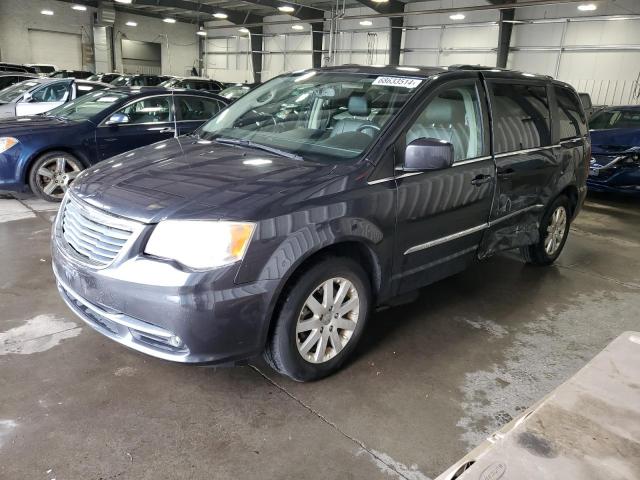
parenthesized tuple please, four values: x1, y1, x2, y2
(489, 83, 551, 153)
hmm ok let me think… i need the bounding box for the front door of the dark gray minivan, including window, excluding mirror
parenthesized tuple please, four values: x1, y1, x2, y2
(394, 75, 495, 293)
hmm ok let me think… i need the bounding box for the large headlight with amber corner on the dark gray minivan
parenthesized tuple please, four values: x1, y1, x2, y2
(144, 220, 255, 269)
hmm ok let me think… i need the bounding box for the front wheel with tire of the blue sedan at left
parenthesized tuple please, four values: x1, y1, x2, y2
(29, 152, 84, 202)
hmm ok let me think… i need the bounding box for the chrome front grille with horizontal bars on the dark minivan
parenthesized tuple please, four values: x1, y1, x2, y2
(60, 199, 135, 266)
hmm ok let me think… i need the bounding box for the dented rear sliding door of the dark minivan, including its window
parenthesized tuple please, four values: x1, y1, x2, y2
(479, 78, 559, 257)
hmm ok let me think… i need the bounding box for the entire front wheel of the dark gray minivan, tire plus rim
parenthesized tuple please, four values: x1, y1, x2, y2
(264, 257, 372, 382)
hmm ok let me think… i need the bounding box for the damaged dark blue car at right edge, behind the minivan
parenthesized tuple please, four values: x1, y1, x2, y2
(587, 105, 640, 196)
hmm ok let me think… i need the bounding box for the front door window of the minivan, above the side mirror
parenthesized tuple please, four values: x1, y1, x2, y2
(406, 82, 483, 162)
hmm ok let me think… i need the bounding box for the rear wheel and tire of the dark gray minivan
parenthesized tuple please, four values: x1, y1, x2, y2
(521, 195, 571, 266)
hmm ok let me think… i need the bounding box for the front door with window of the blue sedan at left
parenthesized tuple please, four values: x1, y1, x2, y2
(96, 94, 175, 160)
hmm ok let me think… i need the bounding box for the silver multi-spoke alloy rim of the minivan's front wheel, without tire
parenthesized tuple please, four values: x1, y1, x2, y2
(296, 277, 360, 363)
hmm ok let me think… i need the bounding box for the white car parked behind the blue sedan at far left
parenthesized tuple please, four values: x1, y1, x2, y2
(0, 78, 111, 118)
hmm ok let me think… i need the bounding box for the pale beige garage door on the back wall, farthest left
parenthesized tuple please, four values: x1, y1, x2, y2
(29, 30, 82, 70)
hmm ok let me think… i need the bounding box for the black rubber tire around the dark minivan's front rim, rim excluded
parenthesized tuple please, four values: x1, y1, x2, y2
(274, 257, 372, 381)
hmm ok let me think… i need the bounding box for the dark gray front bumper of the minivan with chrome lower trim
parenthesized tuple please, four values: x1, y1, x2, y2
(52, 202, 279, 364)
